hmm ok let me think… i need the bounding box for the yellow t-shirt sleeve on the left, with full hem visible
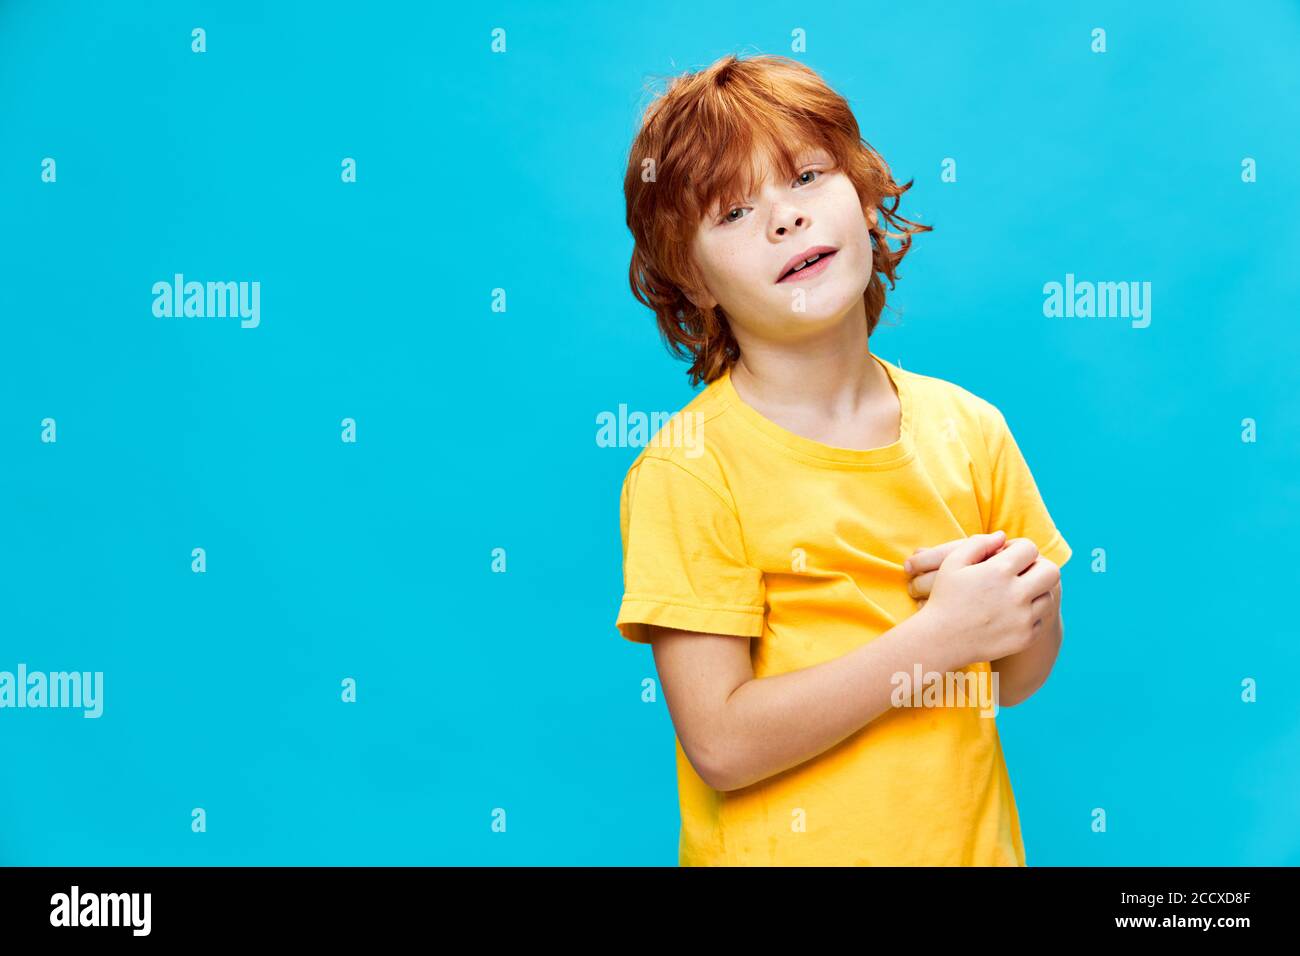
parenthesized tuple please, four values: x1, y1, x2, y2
(615, 458, 767, 644)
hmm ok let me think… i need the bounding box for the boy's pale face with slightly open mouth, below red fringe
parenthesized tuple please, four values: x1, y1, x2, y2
(688, 148, 876, 351)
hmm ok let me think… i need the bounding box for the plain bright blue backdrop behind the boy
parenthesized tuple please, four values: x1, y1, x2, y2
(0, 1, 1300, 865)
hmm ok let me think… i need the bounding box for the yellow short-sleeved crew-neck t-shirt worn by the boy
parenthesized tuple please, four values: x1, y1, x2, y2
(616, 356, 1071, 866)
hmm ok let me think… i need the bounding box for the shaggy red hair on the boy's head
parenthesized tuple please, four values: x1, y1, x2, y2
(623, 53, 932, 385)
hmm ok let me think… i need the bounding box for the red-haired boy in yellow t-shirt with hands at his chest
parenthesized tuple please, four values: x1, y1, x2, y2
(616, 56, 1070, 866)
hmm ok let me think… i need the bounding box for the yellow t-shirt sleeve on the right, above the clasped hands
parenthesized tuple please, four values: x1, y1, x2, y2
(983, 405, 1073, 567)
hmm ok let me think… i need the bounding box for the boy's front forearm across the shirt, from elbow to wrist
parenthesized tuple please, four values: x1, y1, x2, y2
(712, 611, 950, 790)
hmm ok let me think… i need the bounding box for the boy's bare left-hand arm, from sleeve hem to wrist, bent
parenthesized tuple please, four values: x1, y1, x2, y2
(651, 610, 957, 791)
